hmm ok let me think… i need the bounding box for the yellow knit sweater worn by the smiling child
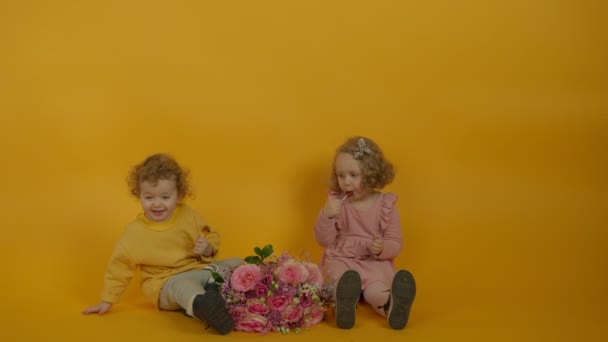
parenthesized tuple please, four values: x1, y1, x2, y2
(101, 204, 220, 305)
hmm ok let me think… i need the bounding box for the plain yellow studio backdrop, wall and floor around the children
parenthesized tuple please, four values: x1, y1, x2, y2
(0, 0, 608, 341)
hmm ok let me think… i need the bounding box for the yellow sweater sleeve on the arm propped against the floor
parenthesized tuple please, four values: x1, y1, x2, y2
(101, 241, 137, 304)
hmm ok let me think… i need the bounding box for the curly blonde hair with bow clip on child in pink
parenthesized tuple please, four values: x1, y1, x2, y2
(329, 136, 395, 192)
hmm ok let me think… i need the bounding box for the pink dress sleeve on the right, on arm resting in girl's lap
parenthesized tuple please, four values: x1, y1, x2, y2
(378, 192, 403, 260)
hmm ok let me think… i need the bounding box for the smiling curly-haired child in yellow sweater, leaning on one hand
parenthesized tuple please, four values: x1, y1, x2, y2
(82, 154, 242, 335)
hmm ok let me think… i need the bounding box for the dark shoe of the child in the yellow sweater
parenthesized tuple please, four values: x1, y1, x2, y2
(192, 290, 234, 335)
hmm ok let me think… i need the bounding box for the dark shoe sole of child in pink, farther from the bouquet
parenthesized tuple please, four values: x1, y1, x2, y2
(386, 270, 416, 330)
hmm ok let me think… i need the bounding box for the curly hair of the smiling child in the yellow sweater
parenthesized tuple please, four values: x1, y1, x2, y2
(127, 153, 192, 199)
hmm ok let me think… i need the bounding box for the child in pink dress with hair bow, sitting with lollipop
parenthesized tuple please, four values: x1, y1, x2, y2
(315, 137, 416, 329)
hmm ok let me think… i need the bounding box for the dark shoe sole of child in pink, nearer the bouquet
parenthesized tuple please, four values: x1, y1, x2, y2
(336, 270, 361, 329)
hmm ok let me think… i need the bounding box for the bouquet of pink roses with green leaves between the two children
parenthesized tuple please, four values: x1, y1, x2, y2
(213, 245, 333, 334)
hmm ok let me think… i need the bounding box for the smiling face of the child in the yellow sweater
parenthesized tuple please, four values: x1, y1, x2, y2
(139, 179, 179, 222)
